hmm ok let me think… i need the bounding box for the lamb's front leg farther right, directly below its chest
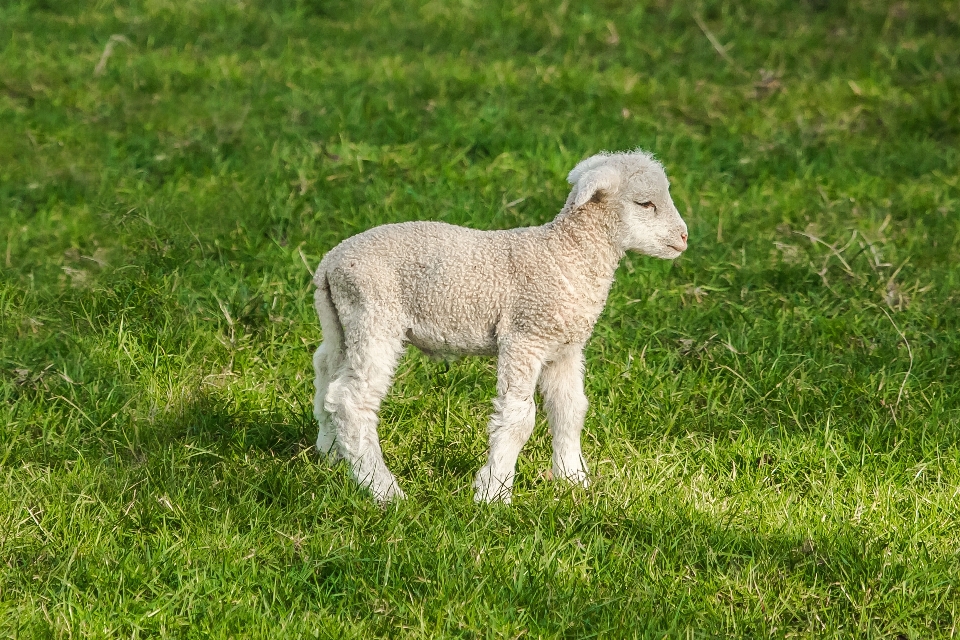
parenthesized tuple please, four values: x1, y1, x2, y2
(540, 345, 589, 487)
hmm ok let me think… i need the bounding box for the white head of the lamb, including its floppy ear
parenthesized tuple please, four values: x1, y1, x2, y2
(567, 150, 687, 259)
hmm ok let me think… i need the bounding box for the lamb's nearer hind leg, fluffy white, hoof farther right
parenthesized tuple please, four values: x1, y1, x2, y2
(324, 336, 403, 502)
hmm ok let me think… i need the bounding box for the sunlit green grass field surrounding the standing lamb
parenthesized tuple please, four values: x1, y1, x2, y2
(0, 0, 960, 638)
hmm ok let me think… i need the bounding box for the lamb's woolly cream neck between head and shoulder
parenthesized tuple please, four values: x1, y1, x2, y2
(548, 203, 623, 286)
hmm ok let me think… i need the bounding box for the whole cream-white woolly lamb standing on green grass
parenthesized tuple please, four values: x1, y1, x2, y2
(313, 150, 687, 502)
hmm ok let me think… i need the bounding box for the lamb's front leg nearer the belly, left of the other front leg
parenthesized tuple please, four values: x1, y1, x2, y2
(474, 344, 543, 502)
